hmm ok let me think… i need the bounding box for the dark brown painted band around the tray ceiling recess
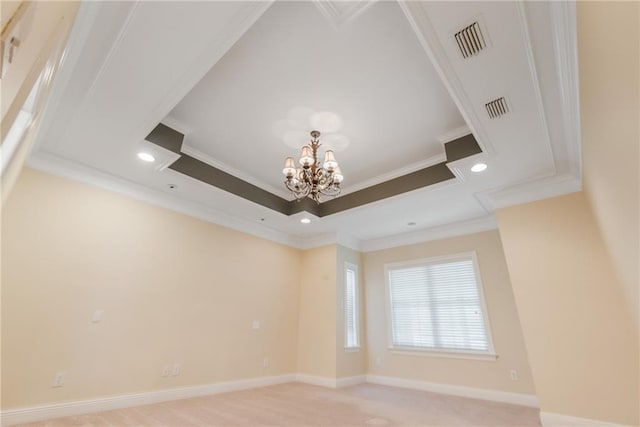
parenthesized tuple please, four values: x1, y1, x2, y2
(145, 123, 482, 218)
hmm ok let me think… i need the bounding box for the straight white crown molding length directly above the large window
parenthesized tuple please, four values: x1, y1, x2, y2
(361, 215, 498, 252)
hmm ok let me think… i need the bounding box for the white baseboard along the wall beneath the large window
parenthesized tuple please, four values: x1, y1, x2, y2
(367, 375, 539, 408)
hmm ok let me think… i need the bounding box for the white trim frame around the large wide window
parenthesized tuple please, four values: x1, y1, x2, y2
(384, 251, 498, 361)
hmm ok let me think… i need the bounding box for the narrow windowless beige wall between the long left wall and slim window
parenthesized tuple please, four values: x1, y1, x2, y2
(298, 245, 337, 378)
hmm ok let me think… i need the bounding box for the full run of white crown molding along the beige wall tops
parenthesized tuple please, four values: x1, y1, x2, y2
(27, 153, 581, 252)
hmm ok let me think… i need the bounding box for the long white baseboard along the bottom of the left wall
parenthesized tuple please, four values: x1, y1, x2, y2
(0, 374, 296, 426)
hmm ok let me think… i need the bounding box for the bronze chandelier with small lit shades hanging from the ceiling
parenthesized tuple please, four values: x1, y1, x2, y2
(282, 130, 344, 203)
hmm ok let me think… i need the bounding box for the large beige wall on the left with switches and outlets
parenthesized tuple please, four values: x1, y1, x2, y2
(2, 169, 302, 409)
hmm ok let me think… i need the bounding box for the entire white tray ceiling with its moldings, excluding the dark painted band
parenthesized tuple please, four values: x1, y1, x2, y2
(29, 1, 581, 250)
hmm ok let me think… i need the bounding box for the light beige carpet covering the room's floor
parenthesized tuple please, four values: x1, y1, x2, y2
(16, 383, 540, 427)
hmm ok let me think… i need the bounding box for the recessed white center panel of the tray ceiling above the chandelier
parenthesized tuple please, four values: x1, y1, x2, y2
(163, 2, 464, 194)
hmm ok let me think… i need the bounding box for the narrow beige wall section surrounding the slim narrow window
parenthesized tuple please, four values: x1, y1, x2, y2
(336, 246, 367, 378)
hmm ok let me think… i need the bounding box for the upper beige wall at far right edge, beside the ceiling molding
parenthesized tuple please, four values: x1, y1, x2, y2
(577, 1, 640, 324)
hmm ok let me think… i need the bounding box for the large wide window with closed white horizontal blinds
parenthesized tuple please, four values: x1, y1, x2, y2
(385, 253, 494, 356)
